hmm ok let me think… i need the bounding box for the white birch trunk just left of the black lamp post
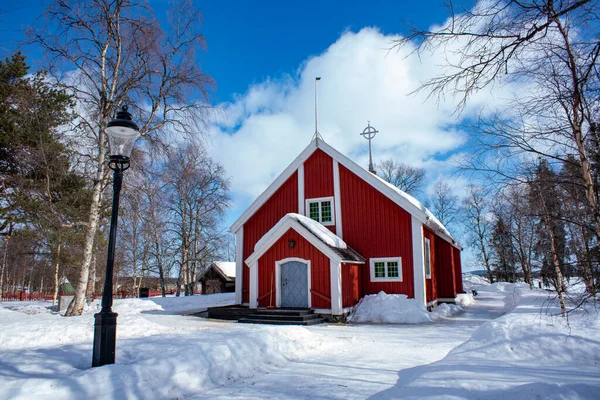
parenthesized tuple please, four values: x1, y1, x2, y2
(65, 150, 105, 317)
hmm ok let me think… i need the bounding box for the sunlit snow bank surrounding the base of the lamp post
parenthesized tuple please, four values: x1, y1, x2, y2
(0, 295, 336, 399)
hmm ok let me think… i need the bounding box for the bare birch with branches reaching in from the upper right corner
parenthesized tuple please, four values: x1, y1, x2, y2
(395, 0, 600, 250)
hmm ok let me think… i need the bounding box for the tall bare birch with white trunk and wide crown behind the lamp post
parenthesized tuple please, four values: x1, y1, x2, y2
(30, 0, 213, 315)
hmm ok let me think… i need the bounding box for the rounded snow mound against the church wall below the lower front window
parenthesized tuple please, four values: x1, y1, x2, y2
(349, 291, 431, 324)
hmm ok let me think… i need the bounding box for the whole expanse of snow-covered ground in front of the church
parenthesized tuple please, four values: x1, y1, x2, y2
(0, 281, 600, 399)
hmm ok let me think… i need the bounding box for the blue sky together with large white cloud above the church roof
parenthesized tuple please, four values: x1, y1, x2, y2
(0, 0, 492, 268)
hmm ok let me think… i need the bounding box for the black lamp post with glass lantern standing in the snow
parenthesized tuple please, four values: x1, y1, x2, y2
(92, 105, 140, 367)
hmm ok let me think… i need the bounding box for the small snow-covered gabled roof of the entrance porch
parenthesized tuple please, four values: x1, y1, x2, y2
(245, 213, 365, 267)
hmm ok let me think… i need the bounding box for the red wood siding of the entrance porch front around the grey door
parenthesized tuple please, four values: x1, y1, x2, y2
(256, 228, 331, 309)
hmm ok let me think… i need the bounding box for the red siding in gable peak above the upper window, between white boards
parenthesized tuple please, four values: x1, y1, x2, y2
(304, 149, 336, 233)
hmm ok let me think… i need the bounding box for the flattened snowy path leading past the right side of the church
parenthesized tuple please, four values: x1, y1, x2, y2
(198, 292, 504, 399)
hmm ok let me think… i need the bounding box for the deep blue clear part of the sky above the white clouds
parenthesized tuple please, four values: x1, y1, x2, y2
(0, 0, 473, 104)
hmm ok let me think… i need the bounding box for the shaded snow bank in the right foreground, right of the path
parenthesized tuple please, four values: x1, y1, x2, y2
(381, 284, 600, 399)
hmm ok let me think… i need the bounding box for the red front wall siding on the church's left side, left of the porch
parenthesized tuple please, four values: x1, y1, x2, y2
(242, 172, 298, 303)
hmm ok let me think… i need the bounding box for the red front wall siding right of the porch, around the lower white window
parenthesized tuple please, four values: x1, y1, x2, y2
(340, 165, 414, 297)
